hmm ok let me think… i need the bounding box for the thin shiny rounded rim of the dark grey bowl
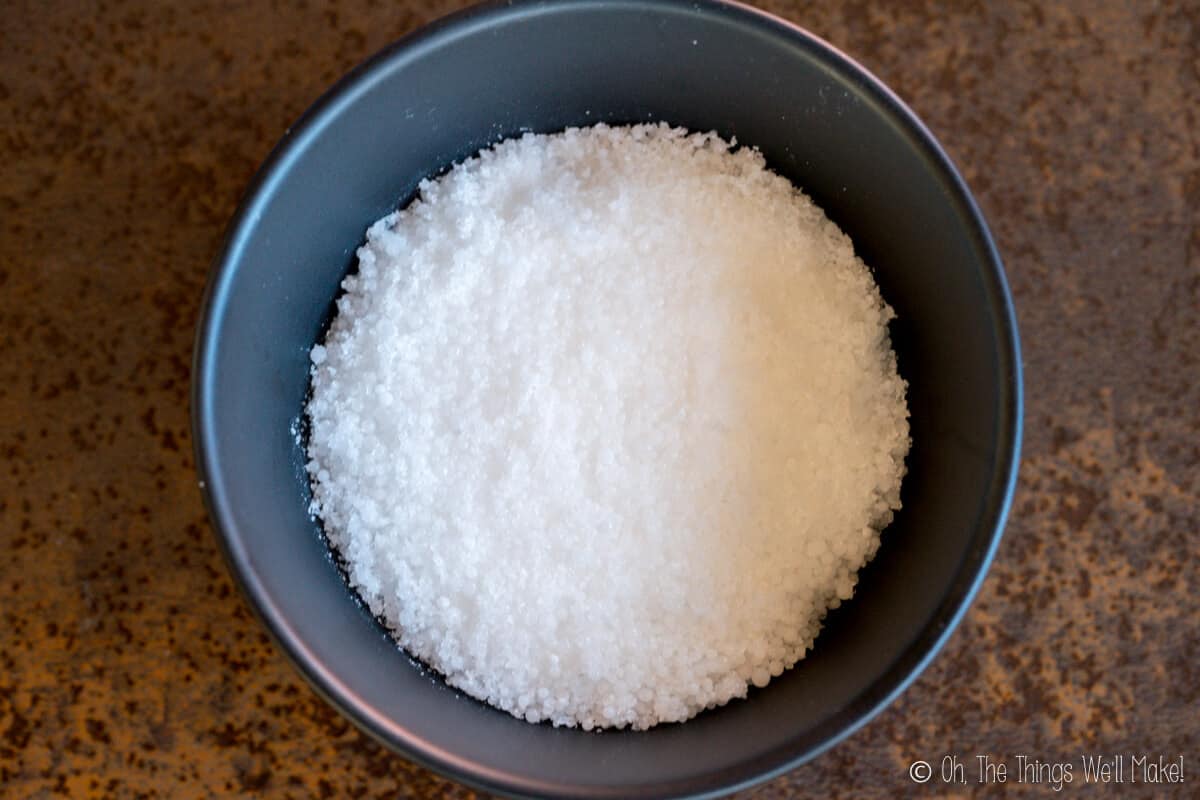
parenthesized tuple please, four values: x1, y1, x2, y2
(191, 0, 1024, 798)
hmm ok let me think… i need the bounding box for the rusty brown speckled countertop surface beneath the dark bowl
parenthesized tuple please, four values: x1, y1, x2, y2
(0, 0, 1200, 799)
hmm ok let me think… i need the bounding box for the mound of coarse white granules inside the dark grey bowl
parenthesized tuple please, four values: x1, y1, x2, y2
(307, 125, 908, 729)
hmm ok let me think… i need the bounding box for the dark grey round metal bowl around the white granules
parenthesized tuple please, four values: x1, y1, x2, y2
(192, 0, 1021, 798)
